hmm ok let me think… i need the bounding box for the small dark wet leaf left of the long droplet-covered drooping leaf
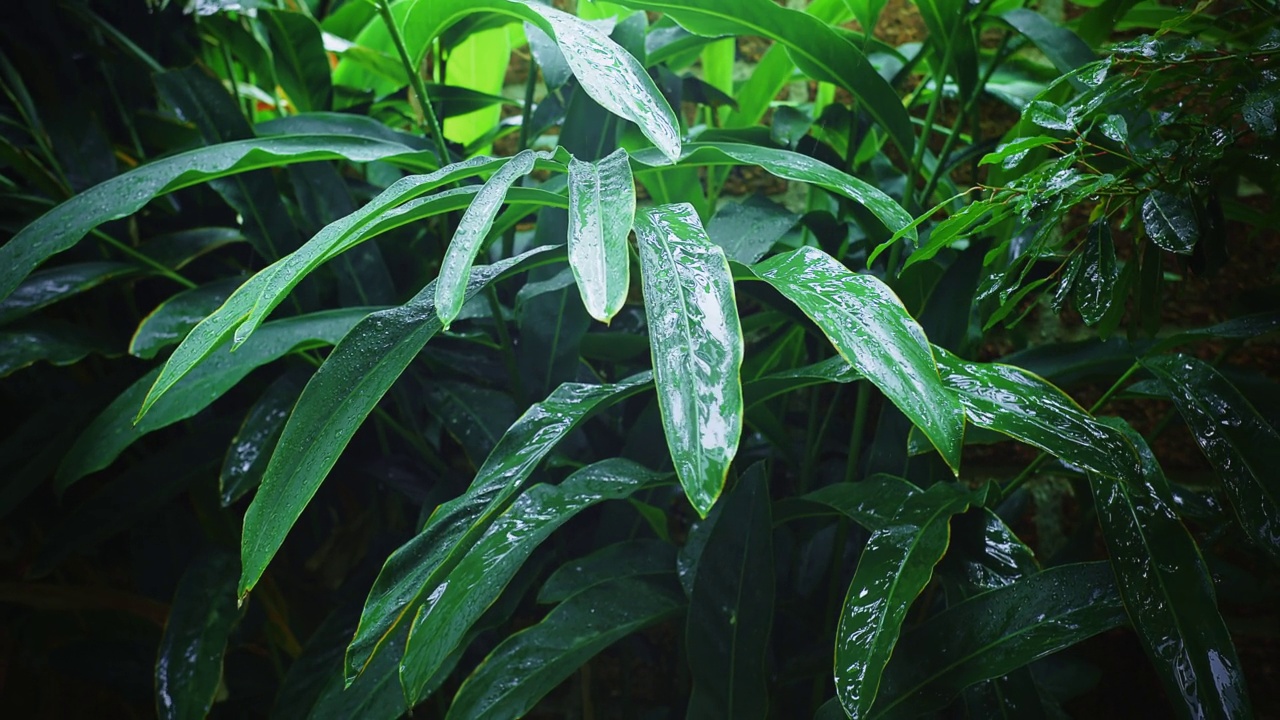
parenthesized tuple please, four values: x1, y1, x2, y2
(218, 373, 306, 507)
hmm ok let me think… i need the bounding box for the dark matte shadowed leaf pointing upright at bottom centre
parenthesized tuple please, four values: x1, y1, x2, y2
(685, 462, 774, 719)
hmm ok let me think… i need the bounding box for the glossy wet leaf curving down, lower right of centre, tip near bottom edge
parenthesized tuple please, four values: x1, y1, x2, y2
(836, 483, 986, 720)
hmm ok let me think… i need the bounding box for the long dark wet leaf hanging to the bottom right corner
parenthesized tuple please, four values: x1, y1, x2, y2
(1089, 417, 1252, 719)
